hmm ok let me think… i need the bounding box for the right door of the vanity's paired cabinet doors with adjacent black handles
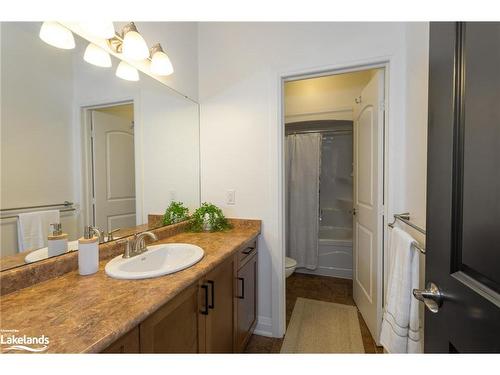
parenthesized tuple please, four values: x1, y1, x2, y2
(202, 258, 234, 353)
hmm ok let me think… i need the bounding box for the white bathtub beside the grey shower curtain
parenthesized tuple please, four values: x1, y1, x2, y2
(296, 226, 352, 279)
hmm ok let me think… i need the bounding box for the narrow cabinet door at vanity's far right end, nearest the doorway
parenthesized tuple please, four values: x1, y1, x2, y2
(235, 255, 257, 352)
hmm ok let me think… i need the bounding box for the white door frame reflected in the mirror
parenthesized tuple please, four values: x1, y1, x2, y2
(79, 97, 142, 231)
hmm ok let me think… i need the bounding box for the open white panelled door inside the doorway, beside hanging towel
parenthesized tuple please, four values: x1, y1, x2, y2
(353, 70, 384, 344)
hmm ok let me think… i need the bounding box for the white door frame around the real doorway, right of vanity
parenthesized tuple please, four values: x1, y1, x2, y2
(271, 56, 393, 342)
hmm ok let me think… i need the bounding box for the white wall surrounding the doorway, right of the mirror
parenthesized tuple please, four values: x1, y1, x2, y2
(199, 22, 428, 335)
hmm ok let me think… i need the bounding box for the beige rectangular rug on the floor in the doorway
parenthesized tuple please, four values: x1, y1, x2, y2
(281, 298, 365, 353)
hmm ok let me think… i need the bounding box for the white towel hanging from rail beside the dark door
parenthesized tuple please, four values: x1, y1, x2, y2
(380, 228, 423, 353)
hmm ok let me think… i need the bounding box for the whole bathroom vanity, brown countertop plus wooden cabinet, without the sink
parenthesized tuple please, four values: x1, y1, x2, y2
(0, 220, 260, 353)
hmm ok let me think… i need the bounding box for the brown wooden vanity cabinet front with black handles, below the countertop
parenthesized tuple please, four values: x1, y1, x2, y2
(103, 242, 257, 353)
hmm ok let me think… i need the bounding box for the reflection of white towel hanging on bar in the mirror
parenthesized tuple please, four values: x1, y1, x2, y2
(17, 210, 60, 252)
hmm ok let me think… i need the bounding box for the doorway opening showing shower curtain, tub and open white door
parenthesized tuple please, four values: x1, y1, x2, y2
(282, 66, 386, 352)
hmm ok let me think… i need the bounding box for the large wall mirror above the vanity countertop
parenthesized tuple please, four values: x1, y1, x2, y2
(0, 22, 200, 270)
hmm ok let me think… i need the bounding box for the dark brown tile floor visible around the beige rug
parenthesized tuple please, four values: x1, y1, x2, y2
(246, 273, 383, 353)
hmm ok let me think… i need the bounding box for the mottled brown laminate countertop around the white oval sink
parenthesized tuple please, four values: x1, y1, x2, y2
(0, 221, 260, 353)
